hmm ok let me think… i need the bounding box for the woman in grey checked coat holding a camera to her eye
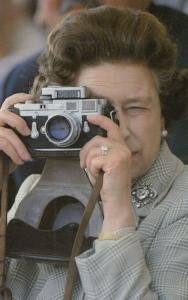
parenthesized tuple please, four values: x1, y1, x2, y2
(0, 7, 188, 300)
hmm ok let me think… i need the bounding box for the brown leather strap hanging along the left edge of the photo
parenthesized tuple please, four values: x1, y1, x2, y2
(0, 156, 12, 300)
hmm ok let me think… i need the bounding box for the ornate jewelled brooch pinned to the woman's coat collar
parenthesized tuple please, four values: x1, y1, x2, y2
(131, 184, 157, 208)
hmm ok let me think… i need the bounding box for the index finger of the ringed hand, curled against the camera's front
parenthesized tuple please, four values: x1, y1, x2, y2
(87, 115, 123, 141)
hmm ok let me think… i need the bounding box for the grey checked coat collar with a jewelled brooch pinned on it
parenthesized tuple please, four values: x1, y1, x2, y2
(132, 141, 184, 217)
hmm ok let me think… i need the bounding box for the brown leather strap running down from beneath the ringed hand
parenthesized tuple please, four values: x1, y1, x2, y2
(64, 172, 103, 300)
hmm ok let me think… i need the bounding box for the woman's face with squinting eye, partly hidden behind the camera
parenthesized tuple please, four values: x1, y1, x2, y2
(77, 63, 163, 178)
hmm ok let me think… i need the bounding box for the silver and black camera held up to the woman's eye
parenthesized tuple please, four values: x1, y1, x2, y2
(11, 86, 107, 158)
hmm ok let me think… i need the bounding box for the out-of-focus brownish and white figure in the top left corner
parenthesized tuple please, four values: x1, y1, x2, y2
(0, 0, 45, 82)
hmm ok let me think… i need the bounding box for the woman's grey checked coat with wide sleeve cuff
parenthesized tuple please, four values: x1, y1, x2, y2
(7, 142, 188, 300)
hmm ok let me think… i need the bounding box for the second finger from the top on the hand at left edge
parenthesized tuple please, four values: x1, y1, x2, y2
(0, 110, 30, 136)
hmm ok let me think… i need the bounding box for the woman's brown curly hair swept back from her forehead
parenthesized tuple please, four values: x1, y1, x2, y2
(33, 6, 177, 127)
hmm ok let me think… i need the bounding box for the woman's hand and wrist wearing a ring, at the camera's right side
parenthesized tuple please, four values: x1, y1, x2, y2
(80, 115, 134, 232)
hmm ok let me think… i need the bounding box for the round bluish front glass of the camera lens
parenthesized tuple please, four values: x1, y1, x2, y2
(46, 116, 71, 141)
